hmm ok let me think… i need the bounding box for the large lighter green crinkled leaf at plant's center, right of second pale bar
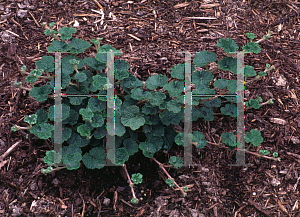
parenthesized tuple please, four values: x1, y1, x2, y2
(121, 106, 145, 130)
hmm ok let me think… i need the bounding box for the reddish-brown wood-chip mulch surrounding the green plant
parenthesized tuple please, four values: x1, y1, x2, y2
(0, 0, 300, 217)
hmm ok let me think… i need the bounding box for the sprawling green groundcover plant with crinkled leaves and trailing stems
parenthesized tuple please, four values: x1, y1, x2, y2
(11, 23, 279, 203)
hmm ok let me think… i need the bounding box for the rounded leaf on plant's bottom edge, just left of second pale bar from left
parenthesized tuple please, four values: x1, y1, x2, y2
(82, 147, 106, 169)
